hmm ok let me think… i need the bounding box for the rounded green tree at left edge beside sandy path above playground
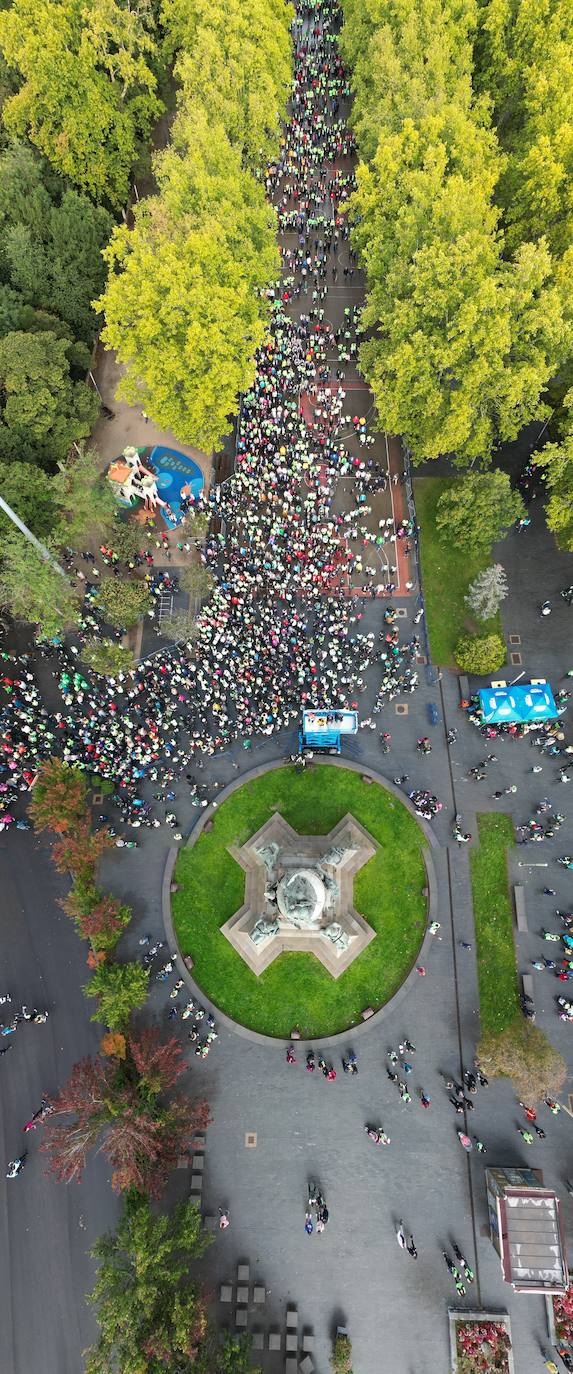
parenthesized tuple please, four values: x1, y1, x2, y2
(0, 327, 99, 463)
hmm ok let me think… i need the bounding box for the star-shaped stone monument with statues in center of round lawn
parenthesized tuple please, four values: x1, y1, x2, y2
(221, 812, 378, 978)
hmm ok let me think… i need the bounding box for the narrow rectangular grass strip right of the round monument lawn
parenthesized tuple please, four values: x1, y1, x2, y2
(470, 815, 519, 1035)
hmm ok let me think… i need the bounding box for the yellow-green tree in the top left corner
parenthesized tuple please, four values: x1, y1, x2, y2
(0, 0, 161, 207)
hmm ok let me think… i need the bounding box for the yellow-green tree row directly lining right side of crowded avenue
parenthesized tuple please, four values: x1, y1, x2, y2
(342, 0, 572, 466)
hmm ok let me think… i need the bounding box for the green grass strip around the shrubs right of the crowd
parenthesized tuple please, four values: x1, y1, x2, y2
(414, 477, 502, 668)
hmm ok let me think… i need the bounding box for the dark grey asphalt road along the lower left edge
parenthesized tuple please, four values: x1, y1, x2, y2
(0, 831, 117, 1374)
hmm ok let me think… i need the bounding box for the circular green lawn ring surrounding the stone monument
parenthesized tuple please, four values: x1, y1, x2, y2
(172, 765, 426, 1039)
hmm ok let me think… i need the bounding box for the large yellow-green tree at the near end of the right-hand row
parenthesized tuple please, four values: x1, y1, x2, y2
(349, 104, 569, 466)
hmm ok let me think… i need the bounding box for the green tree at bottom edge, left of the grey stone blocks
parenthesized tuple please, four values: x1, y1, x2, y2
(87, 1198, 209, 1374)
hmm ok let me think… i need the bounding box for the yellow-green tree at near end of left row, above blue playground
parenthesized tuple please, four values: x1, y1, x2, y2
(96, 109, 278, 452)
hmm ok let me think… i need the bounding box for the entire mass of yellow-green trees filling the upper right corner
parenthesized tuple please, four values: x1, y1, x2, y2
(342, 0, 573, 505)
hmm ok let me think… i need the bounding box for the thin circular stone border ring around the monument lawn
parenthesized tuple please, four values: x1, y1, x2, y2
(161, 757, 439, 1044)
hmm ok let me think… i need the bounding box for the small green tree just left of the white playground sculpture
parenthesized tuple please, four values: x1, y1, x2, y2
(54, 447, 115, 547)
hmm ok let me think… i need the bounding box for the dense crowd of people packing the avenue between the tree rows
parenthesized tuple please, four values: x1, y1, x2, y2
(0, 0, 419, 807)
